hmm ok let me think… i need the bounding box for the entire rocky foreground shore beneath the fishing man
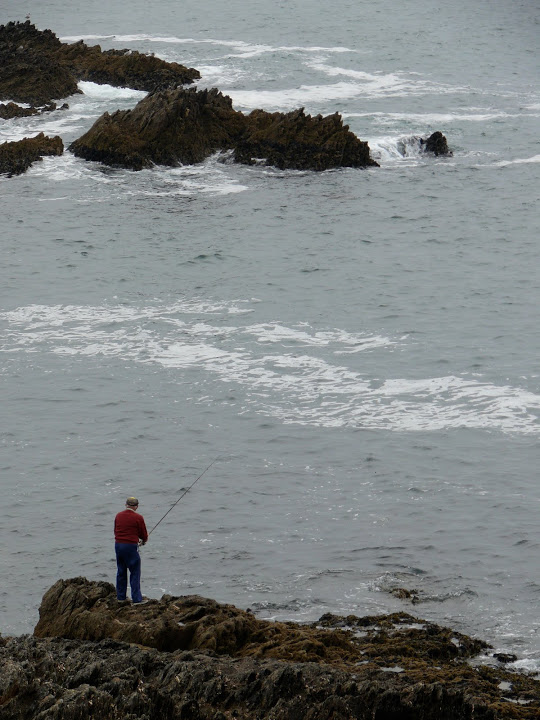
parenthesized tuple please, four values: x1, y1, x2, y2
(0, 577, 540, 720)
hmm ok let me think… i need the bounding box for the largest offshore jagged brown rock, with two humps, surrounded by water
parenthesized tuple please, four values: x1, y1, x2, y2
(69, 88, 377, 170)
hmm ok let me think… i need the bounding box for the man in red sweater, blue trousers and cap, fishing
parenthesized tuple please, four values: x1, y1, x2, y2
(114, 498, 148, 603)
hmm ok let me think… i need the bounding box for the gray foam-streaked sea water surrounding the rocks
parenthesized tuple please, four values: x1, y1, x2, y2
(0, 0, 540, 671)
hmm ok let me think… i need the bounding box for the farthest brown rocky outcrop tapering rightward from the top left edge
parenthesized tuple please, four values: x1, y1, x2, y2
(0, 21, 200, 105)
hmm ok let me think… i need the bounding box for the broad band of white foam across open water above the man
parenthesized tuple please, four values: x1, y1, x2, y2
(0, 300, 540, 434)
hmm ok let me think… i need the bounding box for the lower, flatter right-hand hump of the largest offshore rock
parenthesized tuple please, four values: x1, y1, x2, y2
(234, 108, 378, 170)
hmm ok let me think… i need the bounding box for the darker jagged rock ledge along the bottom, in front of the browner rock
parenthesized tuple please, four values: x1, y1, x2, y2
(0, 637, 524, 720)
